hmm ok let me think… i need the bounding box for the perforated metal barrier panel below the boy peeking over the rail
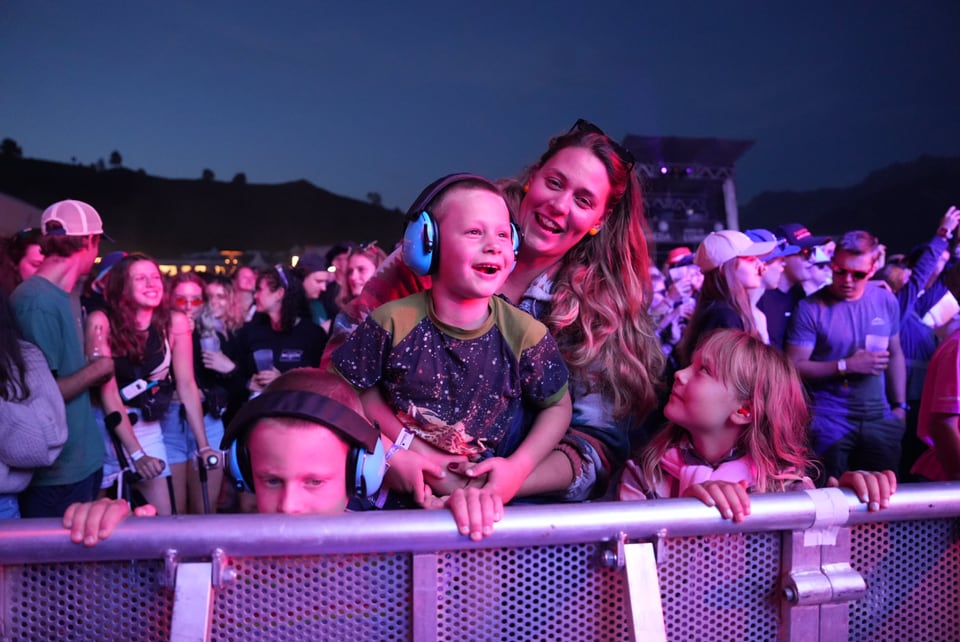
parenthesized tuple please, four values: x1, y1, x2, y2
(211, 554, 412, 642)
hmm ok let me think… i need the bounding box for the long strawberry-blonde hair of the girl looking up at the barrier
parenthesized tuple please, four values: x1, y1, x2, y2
(640, 330, 814, 493)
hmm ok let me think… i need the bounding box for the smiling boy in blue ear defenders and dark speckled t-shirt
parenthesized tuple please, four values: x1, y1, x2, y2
(332, 174, 571, 520)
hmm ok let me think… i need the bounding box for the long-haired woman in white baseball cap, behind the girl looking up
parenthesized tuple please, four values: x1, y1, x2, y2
(676, 230, 777, 367)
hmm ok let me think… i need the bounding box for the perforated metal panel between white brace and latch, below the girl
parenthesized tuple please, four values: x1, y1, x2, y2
(657, 533, 780, 642)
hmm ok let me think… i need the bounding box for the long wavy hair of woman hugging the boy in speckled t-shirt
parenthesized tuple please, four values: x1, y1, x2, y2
(504, 129, 664, 420)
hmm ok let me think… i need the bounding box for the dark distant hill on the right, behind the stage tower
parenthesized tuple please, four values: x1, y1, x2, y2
(740, 156, 960, 253)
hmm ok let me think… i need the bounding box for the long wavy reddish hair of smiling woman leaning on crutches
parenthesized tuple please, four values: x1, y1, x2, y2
(103, 254, 170, 363)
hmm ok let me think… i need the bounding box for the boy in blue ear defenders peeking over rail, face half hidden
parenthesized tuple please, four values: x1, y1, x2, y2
(63, 368, 386, 546)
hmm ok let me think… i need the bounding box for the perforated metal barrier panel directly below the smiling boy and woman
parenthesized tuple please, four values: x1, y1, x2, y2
(437, 544, 629, 642)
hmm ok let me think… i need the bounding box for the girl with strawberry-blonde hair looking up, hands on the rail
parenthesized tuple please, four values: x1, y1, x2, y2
(618, 330, 896, 521)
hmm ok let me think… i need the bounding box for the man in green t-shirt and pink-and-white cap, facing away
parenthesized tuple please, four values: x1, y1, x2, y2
(10, 200, 113, 517)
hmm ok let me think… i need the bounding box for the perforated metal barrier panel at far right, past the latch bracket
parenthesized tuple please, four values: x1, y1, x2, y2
(850, 520, 960, 642)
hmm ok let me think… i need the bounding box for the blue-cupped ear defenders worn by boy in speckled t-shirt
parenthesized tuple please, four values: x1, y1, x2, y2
(402, 173, 522, 276)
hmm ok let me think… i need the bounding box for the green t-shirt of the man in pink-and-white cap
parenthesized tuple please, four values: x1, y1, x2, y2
(10, 276, 104, 486)
